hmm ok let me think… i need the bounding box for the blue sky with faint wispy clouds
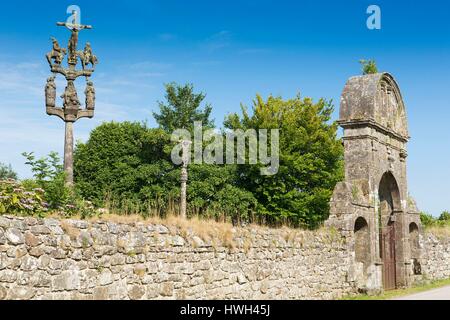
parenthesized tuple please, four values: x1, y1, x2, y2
(0, 0, 450, 215)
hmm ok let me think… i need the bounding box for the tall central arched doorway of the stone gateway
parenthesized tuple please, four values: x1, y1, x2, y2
(378, 172, 401, 290)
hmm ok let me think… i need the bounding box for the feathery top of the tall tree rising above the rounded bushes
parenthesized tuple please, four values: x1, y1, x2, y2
(153, 82, 214, 133)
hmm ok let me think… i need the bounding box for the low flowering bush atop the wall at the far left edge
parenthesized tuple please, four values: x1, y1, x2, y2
(0, 179, 48, 216)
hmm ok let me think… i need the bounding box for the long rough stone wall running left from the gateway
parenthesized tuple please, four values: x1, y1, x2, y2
(0, 216, 353, 299)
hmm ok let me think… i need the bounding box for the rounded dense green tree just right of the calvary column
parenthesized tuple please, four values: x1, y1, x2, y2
(74, 122, 174, 210)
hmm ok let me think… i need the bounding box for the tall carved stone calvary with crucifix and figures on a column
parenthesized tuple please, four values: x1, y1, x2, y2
(45, 12, 98, 186)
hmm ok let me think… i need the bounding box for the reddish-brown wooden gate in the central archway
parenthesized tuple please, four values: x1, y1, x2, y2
(380, 222, 397, 290)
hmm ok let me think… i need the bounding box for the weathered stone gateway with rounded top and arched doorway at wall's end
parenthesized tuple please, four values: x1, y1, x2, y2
(327, 73, 421, 291)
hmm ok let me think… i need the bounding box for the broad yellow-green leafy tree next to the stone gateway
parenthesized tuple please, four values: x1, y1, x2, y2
(225, 95, 343, 228)
